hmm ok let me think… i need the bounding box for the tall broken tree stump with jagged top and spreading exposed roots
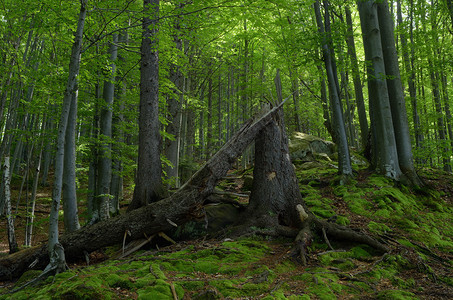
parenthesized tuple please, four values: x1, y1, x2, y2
(235, 110, 387, 265)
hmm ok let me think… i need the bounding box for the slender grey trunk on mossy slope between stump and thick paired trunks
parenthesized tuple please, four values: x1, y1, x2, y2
(314, 1, 352, 176)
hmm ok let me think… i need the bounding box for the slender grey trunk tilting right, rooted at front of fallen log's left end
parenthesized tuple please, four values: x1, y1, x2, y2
(47, 0, 87, 266)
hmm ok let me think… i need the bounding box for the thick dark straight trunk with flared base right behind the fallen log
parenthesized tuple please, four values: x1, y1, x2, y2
(128, 0, 164, 211)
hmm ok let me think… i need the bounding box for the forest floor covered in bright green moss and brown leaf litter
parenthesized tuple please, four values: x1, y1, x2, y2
(0, 162, 453, 299)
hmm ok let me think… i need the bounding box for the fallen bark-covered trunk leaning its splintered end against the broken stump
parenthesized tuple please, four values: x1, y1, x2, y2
(0, 102, 284, 280)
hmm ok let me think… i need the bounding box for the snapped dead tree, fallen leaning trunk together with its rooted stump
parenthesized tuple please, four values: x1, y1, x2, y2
(0, 102, 386, 280)
